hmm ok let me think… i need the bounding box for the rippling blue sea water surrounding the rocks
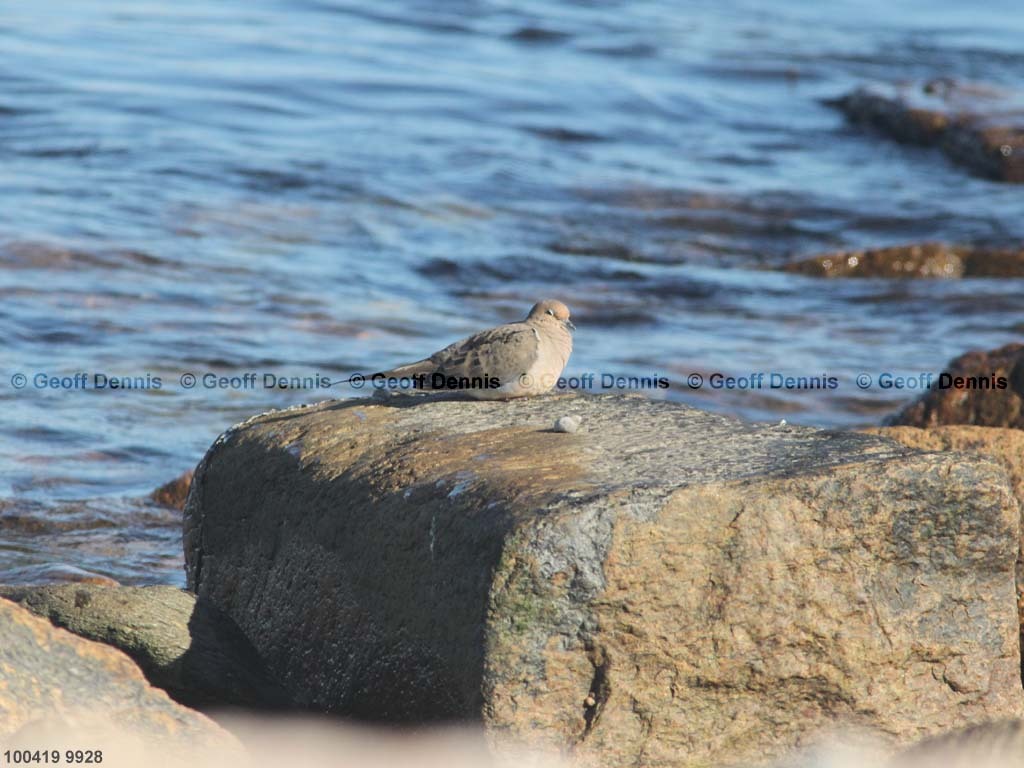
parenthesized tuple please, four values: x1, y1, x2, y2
(0, 0, 1024, 583)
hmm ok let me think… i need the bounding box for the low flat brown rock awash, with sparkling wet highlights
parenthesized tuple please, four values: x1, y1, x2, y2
(784, 243, 1024, 278)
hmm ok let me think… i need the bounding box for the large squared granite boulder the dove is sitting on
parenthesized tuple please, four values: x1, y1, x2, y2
(184, 395, 1024, 766)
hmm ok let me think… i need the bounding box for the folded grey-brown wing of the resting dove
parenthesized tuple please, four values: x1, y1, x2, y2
(430, 323, 541, 384)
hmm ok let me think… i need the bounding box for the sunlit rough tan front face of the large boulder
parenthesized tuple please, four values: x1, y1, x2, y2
(492, 461, 1020, 766)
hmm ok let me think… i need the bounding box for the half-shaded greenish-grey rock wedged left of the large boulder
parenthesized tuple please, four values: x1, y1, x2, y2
(0, 585, 287, 709)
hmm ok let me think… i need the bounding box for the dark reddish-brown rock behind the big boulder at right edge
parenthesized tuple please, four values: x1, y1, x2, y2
(887, 344, 1024, 429)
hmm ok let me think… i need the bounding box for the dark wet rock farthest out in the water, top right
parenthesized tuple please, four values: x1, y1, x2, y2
(826, 80, 1024, 183)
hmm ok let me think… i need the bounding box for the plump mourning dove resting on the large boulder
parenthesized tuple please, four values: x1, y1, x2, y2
(371, 299, 575, 400)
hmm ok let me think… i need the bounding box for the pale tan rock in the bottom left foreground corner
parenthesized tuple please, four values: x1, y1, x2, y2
(0, 599, 231, 762)
